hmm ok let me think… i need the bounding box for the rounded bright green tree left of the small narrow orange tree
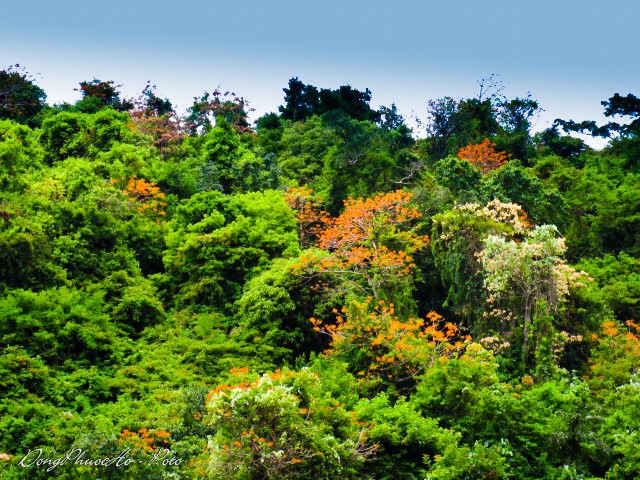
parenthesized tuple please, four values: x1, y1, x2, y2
(164, 190, 298, 312)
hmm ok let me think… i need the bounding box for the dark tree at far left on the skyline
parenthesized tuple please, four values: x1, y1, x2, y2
(0, 64, 47, 127)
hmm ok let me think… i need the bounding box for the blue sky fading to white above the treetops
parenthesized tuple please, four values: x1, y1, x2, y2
(0, 0, 640, 147)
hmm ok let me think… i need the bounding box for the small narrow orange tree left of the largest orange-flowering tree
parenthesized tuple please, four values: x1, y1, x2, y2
(284, 186, 329, 248)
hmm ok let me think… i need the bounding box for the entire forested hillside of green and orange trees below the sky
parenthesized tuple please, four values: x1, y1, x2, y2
(0, 66, 640, 480)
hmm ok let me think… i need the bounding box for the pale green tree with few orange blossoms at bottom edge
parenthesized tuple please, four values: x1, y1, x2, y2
(205, 368, 375, 480)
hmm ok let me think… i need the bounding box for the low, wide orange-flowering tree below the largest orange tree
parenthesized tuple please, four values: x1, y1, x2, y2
(311, 297, 471, 384)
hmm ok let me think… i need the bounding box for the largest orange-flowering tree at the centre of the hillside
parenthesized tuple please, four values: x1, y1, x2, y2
(303, 190, 429, 310)
